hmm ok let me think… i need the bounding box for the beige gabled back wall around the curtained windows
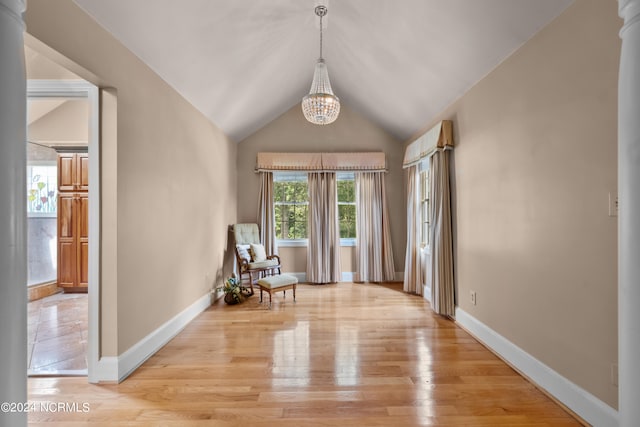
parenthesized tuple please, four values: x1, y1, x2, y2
(237, 104, 406, 272)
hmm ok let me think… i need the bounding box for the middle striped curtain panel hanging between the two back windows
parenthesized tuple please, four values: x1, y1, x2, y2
(307, 172, 340, 283)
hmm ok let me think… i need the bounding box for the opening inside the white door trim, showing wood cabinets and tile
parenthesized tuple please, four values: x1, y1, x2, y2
(27, 95, 89, 376)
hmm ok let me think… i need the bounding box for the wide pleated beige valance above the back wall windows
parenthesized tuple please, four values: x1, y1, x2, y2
(256, 152, 387, 172)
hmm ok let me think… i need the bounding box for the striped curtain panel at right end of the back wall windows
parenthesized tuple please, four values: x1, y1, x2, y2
(355, 172, 395, 282)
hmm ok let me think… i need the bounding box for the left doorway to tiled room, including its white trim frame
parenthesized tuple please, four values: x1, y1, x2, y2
(27, 80, 100, 376)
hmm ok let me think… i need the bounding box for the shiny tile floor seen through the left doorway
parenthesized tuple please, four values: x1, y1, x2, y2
(28, 293, 88, 375)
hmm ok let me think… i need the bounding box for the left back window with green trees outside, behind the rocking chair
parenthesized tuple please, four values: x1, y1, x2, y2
(273, 172, 309, 240)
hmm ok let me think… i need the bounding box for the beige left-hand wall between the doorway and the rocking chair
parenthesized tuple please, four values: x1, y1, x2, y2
(25, 0, 236, 356)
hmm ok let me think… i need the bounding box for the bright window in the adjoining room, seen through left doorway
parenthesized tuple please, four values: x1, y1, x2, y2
(27, 162, 58, 216)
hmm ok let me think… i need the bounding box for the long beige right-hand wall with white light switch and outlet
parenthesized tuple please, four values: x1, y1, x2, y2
(410, 0, 621, 407)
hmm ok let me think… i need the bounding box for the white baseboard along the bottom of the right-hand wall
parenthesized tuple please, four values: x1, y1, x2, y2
(456, 308, 618, 427)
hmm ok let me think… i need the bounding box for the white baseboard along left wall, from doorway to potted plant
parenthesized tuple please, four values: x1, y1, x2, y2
(89, 293, 214, 382)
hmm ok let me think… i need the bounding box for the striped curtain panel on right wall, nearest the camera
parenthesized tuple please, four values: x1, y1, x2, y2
(429, 149, 455, 317)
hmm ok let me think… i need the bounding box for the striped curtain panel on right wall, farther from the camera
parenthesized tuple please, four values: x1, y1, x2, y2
(403, 164, 422, 295)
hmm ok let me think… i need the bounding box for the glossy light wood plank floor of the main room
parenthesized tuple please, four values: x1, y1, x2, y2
(29, 283, 580, 427)
